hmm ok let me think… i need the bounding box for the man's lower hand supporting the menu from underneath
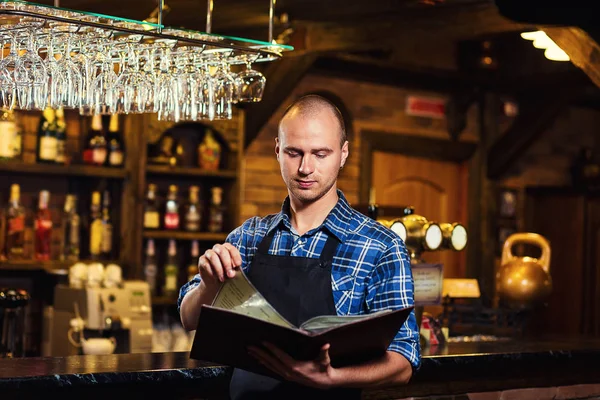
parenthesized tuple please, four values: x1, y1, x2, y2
(248, 342, 336, 389)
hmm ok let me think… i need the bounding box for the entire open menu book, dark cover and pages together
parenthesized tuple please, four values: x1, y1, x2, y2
(190, 269, 412, 376)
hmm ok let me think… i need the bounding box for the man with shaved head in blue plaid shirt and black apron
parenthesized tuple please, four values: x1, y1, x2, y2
(178, 95, 420, 400)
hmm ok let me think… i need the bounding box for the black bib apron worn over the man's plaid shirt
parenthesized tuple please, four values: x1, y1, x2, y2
(229, 229, 361, 400)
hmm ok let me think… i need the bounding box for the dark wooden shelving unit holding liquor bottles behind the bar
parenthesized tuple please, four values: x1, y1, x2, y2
(0, 110, 244, 308)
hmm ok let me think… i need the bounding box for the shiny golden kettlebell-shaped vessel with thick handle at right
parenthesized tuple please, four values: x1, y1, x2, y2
(496, 233, 552, 307)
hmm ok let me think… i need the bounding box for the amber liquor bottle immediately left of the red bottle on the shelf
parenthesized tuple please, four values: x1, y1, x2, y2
(6, 184, 25, 260)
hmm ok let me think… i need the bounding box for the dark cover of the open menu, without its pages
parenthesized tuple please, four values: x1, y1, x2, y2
(190, 305, 413, 376)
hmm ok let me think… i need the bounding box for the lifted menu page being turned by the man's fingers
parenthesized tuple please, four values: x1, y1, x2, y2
(212, 269, 294, 328)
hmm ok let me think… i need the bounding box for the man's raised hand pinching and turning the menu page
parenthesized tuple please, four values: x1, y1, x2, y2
(198, 243, 242, 290)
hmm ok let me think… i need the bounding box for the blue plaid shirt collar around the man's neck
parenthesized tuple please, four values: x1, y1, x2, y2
(267, 189, 352, 243)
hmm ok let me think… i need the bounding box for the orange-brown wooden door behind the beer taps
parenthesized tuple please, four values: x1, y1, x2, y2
(371, 151, 468, 278)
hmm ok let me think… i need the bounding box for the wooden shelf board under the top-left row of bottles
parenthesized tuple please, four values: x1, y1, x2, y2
(0, 161, 127, 179)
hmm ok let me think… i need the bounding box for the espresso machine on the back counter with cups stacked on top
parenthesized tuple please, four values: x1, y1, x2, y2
(42, 281, 153, 356)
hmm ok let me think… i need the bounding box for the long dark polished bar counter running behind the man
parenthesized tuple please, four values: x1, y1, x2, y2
(0, 339, 600, 400)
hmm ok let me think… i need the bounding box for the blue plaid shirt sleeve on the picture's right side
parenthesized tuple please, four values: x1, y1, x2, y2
(366, 238, 421, 369)
